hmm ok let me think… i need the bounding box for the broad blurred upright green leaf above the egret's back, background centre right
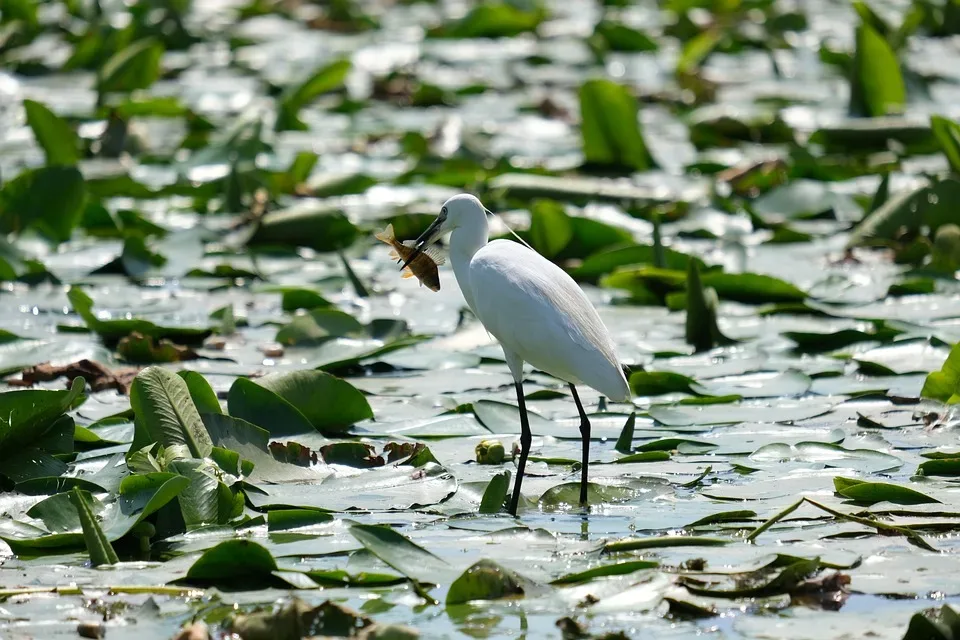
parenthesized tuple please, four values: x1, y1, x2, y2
(580, 79, 656, 171)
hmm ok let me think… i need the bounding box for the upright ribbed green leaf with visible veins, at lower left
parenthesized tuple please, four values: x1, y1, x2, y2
(130, 367, 213, 458)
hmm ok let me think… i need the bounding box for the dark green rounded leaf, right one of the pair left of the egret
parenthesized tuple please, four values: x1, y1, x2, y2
(251, 371, 373, 433)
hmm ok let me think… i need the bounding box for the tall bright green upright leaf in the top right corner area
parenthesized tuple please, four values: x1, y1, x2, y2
(850, 24, 907, 117)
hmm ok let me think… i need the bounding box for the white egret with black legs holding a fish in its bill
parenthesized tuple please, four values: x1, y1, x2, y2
(401, 194, 630, 515)
